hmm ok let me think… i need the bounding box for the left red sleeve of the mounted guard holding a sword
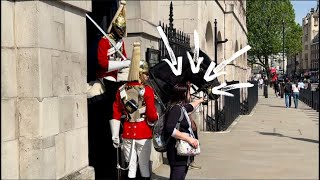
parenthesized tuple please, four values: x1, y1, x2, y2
(98, 38, 110, 71)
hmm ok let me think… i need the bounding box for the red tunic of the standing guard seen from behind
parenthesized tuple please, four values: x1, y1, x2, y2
(113, 82, 158, 139)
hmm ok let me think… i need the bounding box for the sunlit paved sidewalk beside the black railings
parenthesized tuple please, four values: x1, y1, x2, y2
(152, 88, 319, 180)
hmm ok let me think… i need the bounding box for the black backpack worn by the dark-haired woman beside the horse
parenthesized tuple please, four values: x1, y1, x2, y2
(152, 108, 183, 152)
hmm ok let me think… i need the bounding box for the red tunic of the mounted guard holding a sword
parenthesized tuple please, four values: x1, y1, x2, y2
(97, 37, 127, 79)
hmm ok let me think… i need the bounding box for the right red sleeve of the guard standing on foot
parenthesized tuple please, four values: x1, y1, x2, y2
(144, 86, 158, 122)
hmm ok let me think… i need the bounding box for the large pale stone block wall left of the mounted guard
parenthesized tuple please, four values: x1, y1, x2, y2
(1, 1, 93, 179)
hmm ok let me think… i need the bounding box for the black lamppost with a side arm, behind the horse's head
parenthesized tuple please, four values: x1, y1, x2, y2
(214, 19, 228, 131)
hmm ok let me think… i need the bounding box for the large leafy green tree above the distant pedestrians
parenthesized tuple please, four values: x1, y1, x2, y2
(246, 0, 302, 79)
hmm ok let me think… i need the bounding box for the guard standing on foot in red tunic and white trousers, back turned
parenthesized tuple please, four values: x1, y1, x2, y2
(110, 43, 158, 179)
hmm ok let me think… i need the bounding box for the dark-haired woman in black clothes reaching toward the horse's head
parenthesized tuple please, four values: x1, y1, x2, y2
(165, 84, 203, 180)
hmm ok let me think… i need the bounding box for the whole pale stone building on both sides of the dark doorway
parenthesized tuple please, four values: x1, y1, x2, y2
(1, 0, 249, 179)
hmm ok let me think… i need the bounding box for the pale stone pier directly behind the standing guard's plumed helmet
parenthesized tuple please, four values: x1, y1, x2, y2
(124, 0, 163, 170)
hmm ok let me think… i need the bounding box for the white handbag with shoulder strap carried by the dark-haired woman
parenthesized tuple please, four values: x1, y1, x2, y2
(175, 107, 200, 156)
